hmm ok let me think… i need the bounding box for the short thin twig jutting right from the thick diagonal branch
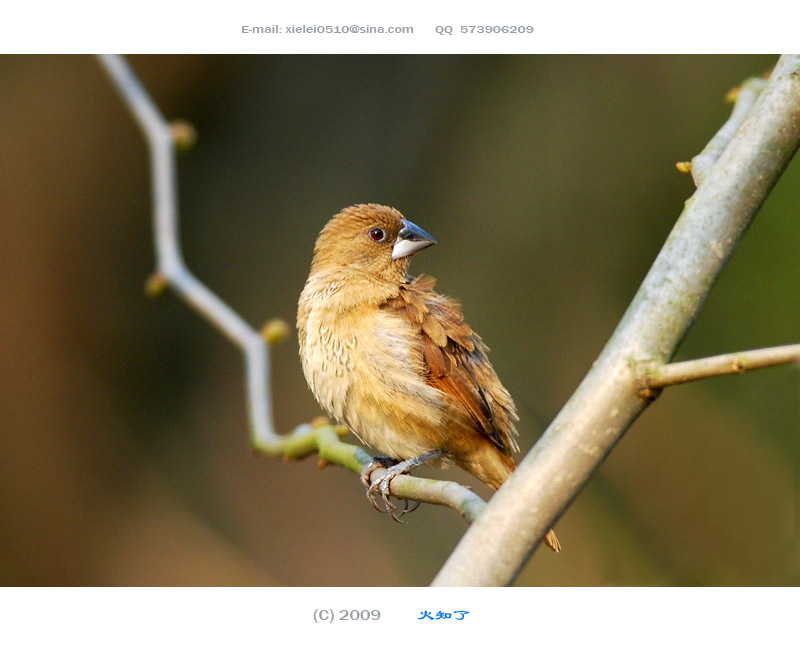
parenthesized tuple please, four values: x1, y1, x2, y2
(639, 344, 800, 390)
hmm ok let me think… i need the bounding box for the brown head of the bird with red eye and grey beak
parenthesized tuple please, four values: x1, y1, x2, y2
(311, 203, 436, 282)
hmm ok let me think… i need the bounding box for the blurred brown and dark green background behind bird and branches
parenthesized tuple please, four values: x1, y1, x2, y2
(0, 56, 800, 586)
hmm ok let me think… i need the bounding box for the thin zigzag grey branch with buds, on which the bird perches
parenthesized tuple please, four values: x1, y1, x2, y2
(98, 54, 486, 521)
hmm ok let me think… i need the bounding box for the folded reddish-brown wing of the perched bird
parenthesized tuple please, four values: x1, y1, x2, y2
(386, 276, 518, 455)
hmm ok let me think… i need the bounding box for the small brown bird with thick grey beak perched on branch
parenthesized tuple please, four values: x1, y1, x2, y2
(297, 203, 561, 552)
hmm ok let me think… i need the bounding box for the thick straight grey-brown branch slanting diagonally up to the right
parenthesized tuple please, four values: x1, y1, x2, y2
(433, 55, 800, 586)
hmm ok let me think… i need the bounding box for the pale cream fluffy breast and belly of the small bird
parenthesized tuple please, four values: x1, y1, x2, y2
(300, 278, 446, 458)
